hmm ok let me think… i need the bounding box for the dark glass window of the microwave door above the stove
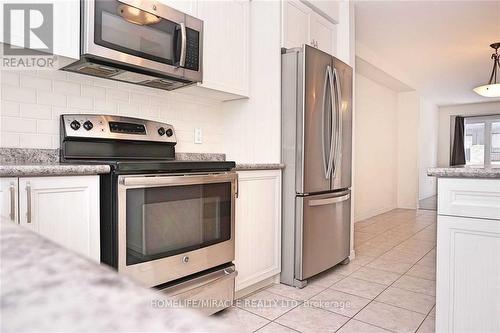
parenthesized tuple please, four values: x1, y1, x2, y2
(94, 0, 181, 65)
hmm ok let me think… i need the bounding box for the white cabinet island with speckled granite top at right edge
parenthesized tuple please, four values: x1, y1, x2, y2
(428, 167, 500, 332)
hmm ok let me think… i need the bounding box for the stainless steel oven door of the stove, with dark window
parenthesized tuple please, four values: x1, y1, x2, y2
(118, 172, 237, 286)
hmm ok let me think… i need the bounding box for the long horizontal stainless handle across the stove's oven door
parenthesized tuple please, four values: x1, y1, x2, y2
(120, 173, 238, 187)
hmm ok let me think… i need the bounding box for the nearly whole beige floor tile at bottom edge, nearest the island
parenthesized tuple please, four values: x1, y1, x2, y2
(354, 302, 425, 332)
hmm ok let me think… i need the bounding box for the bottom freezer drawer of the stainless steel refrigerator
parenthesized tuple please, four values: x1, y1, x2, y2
(295, 190, 351, 280)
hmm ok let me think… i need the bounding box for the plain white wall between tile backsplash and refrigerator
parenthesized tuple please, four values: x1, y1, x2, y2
(223, 1, 281, 163)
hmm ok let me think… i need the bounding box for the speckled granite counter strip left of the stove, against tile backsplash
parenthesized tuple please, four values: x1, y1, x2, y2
(0, 163, 110, 177)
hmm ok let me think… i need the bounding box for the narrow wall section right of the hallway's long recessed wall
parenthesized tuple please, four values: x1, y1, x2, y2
(397, 91, 420, 209)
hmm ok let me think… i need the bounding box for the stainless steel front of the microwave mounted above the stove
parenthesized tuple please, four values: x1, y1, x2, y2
(82, 0, 203, 82)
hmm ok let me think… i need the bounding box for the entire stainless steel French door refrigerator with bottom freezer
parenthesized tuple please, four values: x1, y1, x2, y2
(281, 45, 352, 288)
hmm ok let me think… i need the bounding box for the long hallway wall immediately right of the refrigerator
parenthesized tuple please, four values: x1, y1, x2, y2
(354, 74, 398, 221)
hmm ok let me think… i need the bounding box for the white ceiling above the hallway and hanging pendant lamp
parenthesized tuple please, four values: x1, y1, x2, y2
(355, 0, 500, 105)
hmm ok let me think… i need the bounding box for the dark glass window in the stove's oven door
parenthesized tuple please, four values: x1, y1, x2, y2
(126, 182, 231, 265)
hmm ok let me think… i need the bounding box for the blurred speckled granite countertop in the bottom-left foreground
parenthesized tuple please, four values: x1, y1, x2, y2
(0, 221, 229, 332)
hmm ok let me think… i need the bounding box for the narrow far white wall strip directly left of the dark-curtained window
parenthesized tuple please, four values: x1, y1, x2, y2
(418, 99, 439, 200)
